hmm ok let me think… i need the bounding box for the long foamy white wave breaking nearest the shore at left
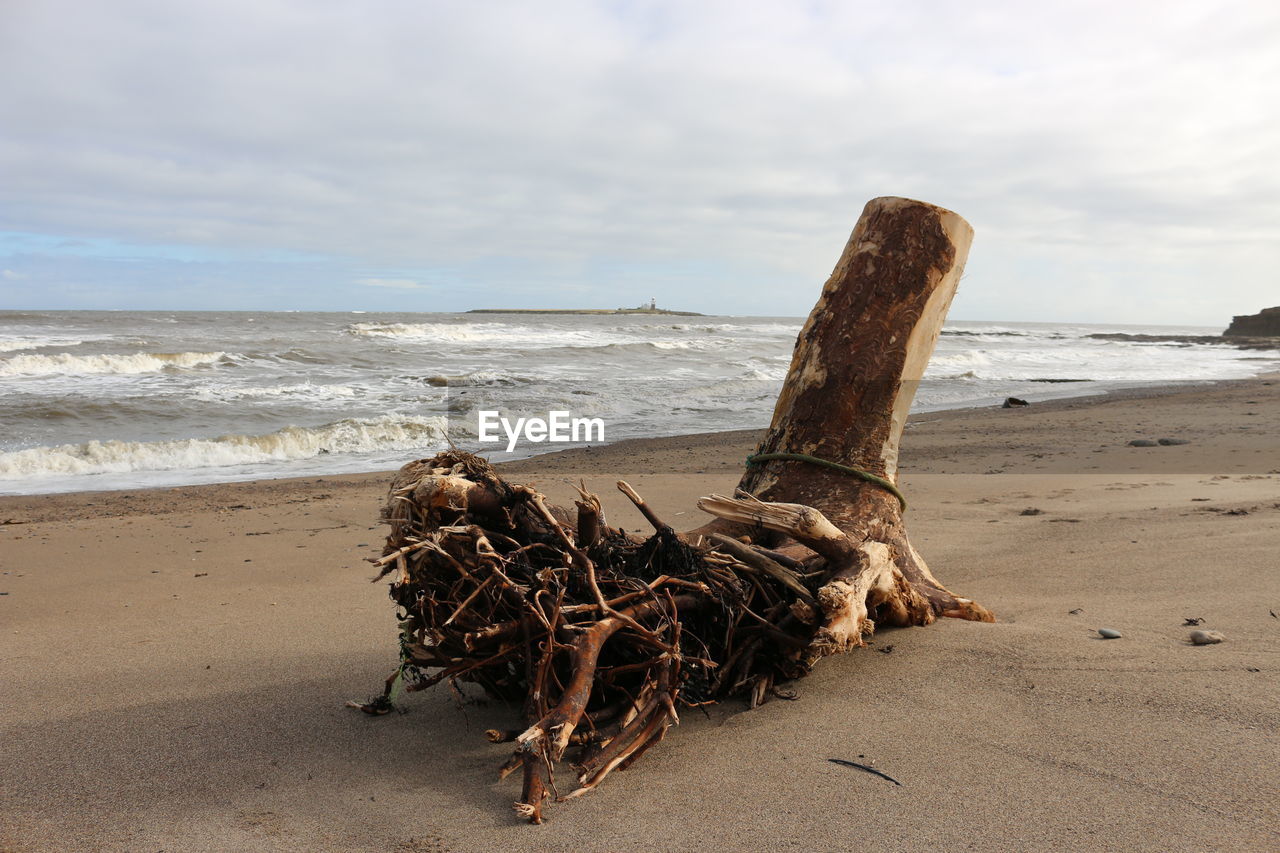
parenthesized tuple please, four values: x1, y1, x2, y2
(0, 415, 448, 480)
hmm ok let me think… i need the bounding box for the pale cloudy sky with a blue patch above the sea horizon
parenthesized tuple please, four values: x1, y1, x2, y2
(0, 0, 1280, 325)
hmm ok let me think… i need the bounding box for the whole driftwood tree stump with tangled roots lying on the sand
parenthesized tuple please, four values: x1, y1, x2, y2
(357, 199, 992, 822)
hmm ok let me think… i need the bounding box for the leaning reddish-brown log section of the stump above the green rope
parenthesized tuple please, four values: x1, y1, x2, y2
(741, 199, 973, 491)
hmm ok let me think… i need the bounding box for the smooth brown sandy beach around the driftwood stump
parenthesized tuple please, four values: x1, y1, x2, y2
(0, 380, 1280, 850)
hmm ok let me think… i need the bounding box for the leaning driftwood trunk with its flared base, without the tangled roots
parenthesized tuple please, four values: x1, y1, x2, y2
(692, 197, 993, 662)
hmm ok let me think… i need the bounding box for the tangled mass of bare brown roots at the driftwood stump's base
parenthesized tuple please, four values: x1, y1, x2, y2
(358, 451, 984, 824)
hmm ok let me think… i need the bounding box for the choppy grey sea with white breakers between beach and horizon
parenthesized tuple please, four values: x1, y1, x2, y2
(0, 311, 1280, 494)
